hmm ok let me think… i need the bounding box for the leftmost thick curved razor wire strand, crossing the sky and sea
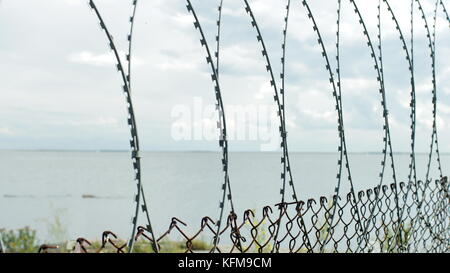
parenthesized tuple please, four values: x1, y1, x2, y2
(89, 0, 159, 252)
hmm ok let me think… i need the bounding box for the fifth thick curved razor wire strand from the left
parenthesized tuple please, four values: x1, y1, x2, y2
(350, 0, 397, 252)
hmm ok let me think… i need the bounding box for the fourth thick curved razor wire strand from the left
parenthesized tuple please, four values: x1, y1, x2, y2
(302, 0, 361, 251)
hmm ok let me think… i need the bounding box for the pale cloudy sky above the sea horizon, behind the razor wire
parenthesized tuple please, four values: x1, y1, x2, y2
(0, 0, 450, 152)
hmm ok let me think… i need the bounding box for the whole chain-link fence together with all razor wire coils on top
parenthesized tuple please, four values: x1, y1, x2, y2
(0, 0, 450, 253)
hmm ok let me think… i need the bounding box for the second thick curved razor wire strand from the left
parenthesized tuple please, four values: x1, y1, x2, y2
(186, 0, 235, 252)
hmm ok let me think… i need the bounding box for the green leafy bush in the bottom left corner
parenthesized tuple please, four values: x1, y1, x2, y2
(0, 227, 39, 253)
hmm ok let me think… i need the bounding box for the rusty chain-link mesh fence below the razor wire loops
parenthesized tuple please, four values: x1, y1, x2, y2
(40, 177, 450, 253)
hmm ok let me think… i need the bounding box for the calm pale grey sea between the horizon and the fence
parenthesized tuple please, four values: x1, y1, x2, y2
(0, 151, 444, 241)
